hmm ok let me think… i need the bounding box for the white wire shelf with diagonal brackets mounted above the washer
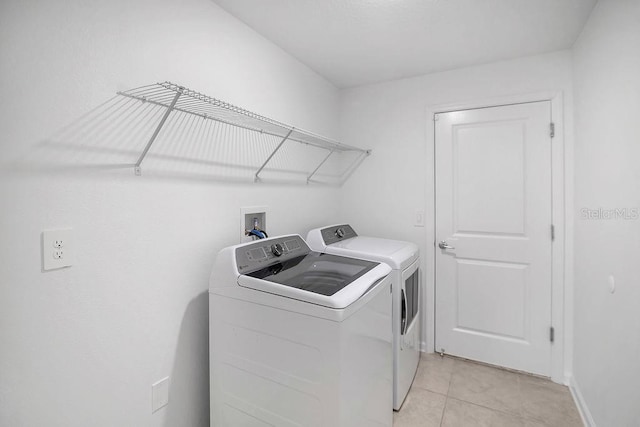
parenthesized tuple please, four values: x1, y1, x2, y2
(118, 82, 371, 183)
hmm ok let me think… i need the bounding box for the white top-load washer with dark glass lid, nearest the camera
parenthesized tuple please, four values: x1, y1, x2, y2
(209, 235, 393, 427)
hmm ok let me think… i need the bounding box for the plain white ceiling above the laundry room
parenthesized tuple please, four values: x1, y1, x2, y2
(213, 0, 597, 88)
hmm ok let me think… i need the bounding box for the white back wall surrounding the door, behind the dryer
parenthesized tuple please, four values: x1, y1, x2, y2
(340, 51, 572, 374)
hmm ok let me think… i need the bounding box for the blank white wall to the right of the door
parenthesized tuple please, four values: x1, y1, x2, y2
(573, 0, 640, 427)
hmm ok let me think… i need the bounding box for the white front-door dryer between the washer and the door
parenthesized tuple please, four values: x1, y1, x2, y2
(307, 224, 421, 410)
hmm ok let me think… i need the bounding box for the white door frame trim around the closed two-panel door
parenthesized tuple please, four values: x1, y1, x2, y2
(422, 91, 573, 385)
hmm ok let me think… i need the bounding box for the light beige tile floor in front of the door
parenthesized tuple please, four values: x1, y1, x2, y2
(393, 353, 583, 427)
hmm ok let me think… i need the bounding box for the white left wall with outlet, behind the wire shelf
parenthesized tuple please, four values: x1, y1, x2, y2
(0, 0, 339, 426)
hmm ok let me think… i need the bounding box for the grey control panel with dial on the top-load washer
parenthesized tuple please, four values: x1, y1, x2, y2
(236, 235, 311, 274)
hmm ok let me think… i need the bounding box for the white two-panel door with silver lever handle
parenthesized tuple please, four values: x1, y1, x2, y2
(435, 101, 552, 376)
